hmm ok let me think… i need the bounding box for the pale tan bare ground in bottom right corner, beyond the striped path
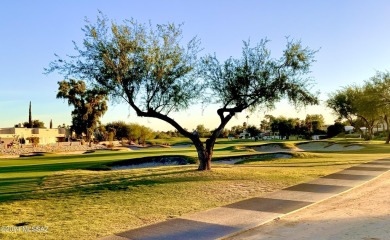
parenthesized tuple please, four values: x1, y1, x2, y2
(225, 168, 390, 240)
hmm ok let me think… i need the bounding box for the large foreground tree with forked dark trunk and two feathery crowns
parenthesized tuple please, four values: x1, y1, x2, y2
(46, 16, 318, 170)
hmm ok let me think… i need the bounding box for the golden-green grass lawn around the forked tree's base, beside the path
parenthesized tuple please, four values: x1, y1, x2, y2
(0, 141, 390, 239)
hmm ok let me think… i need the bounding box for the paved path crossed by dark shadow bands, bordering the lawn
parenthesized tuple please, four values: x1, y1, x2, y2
(102, 158, 390, 240)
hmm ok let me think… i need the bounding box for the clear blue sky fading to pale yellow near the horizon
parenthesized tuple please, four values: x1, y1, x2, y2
(0, 0, 390, 129)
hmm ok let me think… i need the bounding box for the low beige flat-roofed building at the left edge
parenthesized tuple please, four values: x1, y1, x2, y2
(0, 127, 66, 145)
